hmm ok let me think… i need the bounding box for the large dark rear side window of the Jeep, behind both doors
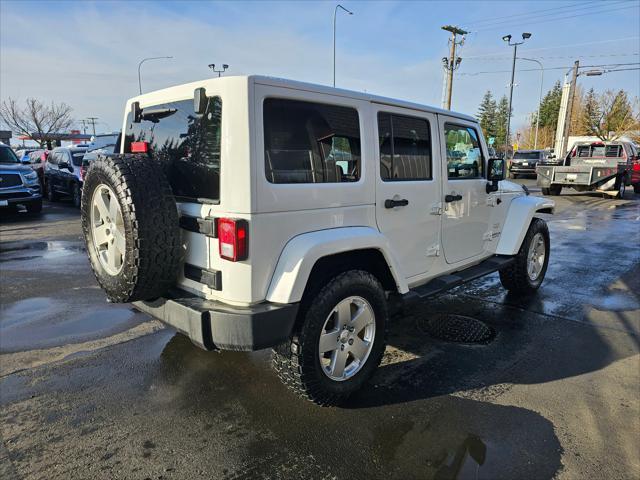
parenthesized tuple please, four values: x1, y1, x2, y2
(264, 98, 360, 183)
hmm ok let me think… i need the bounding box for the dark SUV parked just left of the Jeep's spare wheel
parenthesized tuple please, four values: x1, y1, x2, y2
(44, 147, 87, 208)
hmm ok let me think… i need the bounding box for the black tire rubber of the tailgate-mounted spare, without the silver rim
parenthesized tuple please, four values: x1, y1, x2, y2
(81, 154, 183, 302)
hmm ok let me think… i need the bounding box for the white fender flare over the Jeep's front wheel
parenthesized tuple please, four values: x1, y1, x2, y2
(496, 196, 556, 255)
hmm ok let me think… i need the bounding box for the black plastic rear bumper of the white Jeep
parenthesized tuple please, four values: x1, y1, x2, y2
(133, 292, 298, 351)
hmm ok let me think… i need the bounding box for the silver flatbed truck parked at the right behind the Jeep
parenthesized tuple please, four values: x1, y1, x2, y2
(537, 141, 640, 198)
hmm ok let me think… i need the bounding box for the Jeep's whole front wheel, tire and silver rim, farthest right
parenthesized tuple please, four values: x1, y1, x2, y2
(500, 218, 550, 295)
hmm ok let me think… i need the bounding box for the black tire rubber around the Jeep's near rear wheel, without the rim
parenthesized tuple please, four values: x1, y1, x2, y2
(272, 270, 388, 406)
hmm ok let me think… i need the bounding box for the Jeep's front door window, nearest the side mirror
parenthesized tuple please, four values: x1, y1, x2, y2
(444, 123, 484, 180)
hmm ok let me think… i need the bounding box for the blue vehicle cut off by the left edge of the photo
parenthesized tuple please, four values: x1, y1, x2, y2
(0, 143, 42, 213)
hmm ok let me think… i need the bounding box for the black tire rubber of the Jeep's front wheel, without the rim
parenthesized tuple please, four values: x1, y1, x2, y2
(500, 218, 550, 295)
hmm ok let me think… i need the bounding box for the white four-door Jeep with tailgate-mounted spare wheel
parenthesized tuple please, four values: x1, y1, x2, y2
(82, 76, 554, 405)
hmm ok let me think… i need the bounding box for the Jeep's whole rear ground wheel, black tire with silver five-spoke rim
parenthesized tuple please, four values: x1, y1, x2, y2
(272, 270, 388, 405)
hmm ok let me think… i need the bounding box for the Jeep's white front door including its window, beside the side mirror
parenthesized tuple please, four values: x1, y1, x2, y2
(438, 115, 491, 264)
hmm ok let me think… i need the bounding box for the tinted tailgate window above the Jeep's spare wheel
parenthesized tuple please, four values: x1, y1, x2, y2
(124, 97, 222, 203)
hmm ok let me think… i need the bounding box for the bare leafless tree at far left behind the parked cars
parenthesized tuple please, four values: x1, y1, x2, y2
(0, 98, 73, 147)
